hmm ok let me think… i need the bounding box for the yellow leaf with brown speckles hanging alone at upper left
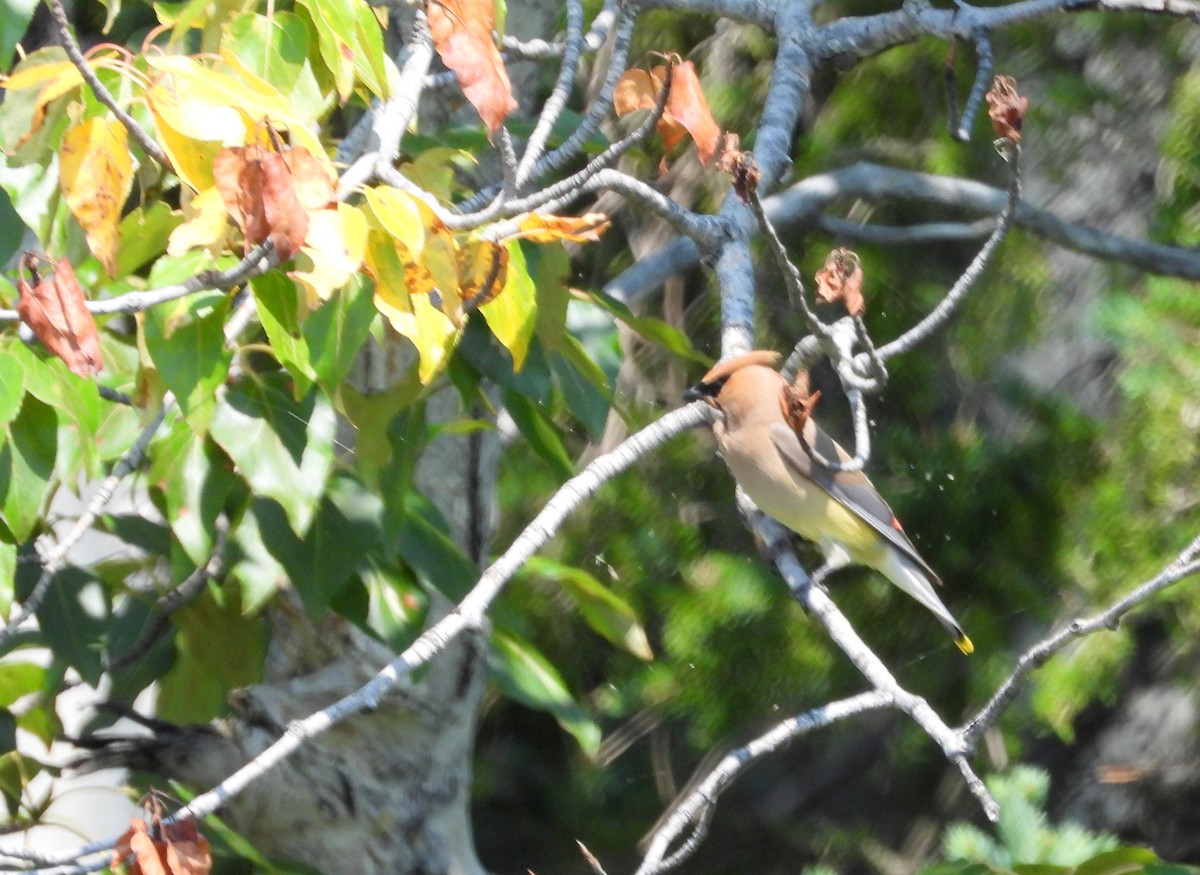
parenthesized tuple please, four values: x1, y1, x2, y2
(59, 118, 133, 276)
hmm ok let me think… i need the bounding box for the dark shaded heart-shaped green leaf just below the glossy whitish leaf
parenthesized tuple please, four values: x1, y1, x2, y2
(251, 477, 383, 616)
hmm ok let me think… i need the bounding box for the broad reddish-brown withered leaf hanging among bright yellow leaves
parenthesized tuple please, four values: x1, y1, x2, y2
(212, 144, 334, 260)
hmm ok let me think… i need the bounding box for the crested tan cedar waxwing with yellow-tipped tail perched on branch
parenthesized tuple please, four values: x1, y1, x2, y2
(685, 350, 974, 653)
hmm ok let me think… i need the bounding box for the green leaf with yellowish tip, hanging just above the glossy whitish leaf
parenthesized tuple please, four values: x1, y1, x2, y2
(142, 292, 233, 434)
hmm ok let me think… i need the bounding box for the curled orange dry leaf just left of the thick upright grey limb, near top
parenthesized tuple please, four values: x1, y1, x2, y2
(613, 61, 721, 167)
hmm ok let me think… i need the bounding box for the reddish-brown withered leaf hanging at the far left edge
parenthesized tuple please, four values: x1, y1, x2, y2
(17, 252, 104, 377)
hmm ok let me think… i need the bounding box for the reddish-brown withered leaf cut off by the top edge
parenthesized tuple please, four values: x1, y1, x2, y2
(425, 0, 517, 137)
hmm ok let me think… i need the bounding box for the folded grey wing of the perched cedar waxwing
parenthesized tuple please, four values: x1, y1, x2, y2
(769, 419, 942, 583)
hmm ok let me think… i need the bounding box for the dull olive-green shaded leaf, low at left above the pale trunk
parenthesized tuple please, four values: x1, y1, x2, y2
(157, 593, 268, 724)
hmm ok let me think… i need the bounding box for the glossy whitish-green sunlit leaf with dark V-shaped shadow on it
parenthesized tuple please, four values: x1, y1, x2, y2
(209, 374, 337, 538)
